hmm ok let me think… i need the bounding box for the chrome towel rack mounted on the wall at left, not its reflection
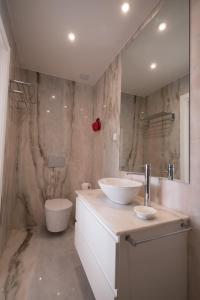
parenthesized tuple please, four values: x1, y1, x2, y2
(10, 79, 37, 112)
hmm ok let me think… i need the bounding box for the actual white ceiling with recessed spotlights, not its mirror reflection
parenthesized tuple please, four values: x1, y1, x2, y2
(7, 0, 159, 84)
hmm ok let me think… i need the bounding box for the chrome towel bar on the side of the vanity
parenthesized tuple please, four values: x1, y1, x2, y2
(125, 223, 192, 247)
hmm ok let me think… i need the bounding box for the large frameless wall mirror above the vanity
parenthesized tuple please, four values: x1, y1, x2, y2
(120, 0, 190, 182)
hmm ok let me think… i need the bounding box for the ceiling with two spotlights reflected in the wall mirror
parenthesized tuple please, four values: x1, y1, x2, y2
(122, 0, 189, 96)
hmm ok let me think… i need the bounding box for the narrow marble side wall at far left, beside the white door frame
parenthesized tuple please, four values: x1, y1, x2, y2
(0, 0, 21, 255)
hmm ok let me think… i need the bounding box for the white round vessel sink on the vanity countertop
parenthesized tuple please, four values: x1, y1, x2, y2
(98, 178, 143, 204)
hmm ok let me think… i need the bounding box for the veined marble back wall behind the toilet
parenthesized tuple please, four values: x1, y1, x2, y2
(12, 70, 93, 228)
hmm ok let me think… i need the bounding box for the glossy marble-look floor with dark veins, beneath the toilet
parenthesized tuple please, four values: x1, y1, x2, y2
(0, 228, 94, 300)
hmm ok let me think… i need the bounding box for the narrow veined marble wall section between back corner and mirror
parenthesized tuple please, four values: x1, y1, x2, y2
(93, 56, 121, 187)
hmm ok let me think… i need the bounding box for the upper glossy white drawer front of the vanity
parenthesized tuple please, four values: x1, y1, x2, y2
(76, 199, 118, 290)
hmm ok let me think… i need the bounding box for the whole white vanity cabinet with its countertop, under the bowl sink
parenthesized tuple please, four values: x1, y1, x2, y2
(75, 190, 188, 300)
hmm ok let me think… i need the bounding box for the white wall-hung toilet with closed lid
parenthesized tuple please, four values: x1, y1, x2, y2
(45, 199, 72, 232)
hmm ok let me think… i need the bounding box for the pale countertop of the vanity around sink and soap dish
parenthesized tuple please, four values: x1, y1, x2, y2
(76, 189, 189, 235)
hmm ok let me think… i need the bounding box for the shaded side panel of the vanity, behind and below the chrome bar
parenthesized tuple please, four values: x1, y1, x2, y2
(118, 229, 187, 300)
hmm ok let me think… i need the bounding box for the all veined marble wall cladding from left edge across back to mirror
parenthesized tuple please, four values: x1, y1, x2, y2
(0, 7, 121, 234)
